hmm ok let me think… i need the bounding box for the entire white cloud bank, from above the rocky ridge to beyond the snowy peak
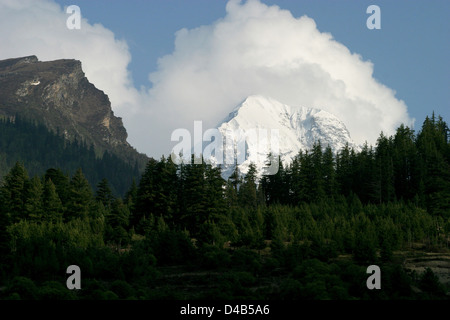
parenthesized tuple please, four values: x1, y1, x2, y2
(0, 0, 411, 157)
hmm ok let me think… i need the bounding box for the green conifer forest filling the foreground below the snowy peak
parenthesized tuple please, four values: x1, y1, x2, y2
(0, 115, 450, 300)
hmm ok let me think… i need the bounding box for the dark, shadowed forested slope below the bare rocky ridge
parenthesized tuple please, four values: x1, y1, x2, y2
(0, 116, 140, 196)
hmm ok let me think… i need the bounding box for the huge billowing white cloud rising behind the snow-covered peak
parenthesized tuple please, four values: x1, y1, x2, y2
(145, 0, 412, 156)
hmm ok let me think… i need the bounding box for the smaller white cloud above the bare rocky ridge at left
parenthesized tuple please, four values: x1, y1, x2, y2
(0, 0, 145, 113)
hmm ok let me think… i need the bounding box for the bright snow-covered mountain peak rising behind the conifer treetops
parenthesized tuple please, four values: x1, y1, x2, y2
(207, 95, 357, 178)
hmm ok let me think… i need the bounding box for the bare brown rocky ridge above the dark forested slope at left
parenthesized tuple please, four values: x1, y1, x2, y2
(0, 56, 147, 168)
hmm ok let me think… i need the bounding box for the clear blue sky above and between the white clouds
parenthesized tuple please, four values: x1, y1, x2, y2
(56, 0, 450, 128)
